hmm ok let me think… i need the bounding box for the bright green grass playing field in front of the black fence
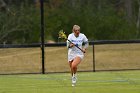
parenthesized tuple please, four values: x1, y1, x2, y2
(0, 71, 140, 93)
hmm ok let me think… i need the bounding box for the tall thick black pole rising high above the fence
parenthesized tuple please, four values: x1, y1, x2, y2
(40, 0, 45, 74)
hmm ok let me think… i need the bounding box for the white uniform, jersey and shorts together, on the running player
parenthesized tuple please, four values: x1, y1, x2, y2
(67, 33, 88, 61)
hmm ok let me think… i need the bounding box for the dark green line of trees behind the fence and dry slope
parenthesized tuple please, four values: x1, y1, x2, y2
(0, 0, 140, 44)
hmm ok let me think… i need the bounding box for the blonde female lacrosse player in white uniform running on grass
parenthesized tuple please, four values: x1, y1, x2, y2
(67, 25, 88, 86)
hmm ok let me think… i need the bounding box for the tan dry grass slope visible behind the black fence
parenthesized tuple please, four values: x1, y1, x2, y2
(0, 44, 140, 74)
